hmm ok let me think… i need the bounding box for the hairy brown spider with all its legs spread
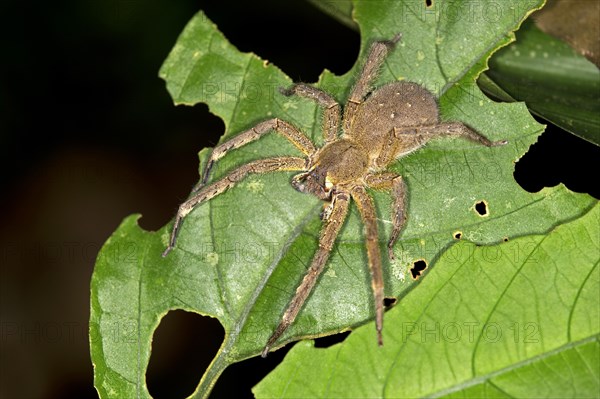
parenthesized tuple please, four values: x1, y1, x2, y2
(163, 35, 506, 357)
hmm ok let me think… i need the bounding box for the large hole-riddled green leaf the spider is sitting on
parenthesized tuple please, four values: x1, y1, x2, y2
(90, 0, 595, 397)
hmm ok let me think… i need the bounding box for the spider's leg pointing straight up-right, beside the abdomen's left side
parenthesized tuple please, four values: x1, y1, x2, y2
(344, 33, 402, 132)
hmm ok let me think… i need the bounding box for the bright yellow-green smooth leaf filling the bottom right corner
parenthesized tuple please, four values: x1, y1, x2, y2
(253, 206, 600, 398)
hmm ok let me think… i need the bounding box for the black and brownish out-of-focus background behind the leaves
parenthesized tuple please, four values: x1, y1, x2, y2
(0, 0, 600, 399)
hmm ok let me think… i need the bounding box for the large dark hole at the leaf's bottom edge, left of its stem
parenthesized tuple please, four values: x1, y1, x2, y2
(146, 310, 225, 398)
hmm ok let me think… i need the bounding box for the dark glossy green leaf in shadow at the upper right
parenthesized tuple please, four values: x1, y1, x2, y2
(479, 21, 600, 145)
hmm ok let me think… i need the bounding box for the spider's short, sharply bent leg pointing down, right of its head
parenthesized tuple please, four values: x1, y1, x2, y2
(365, 172, 408, 260)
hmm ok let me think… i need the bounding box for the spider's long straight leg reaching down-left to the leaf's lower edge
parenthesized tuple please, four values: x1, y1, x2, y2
(261, 192, 349, 357)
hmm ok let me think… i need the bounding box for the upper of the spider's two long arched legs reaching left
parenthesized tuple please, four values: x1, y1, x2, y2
(198, 118, 316, 192)
